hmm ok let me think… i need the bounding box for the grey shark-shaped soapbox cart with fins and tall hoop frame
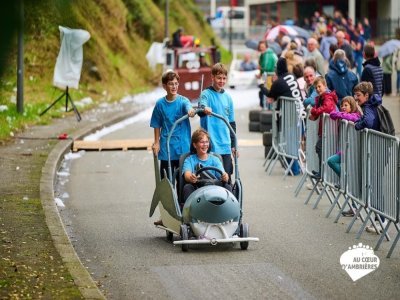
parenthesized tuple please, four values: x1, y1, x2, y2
(149, 109, 259, 251)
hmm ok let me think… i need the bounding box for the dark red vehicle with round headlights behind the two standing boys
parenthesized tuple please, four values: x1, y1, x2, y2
(166, 47, 217, 102)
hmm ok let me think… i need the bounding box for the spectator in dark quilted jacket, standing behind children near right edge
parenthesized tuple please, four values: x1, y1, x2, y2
(360, 44, 383, 97)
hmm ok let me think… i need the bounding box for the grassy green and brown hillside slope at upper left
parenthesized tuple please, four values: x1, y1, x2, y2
(0, 0, 219, 139)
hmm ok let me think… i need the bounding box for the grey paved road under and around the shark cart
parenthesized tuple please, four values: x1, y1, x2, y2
(60, 90, 400, 299)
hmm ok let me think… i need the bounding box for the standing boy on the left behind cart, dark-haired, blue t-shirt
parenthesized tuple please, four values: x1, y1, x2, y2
(150, 70, 195, 178)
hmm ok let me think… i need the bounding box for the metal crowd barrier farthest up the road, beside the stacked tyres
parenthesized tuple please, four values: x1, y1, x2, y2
(265, 97, 304, 178)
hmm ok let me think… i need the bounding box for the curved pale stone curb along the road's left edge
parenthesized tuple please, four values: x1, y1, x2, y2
(40, 108, 140, 299)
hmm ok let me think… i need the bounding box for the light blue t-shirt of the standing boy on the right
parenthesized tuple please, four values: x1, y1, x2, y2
(200, 87, 235, 154)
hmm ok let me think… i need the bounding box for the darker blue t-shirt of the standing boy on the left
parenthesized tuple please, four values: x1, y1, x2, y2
(150, 95, 192, 160)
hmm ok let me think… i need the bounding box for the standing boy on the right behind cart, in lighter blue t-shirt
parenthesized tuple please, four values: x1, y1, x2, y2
(199, 63, 236, 182)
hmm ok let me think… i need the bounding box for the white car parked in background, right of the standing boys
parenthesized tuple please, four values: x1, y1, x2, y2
(228, 49, 260, 88)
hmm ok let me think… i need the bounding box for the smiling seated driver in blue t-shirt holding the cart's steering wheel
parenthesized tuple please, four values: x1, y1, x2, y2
(182, 128, 232, 203)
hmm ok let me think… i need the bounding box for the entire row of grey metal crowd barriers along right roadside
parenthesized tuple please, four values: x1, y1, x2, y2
(264, 98, 400, 257)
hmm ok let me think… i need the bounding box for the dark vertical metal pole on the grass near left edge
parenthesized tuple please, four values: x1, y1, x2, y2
(17, 0, 24, 114)
